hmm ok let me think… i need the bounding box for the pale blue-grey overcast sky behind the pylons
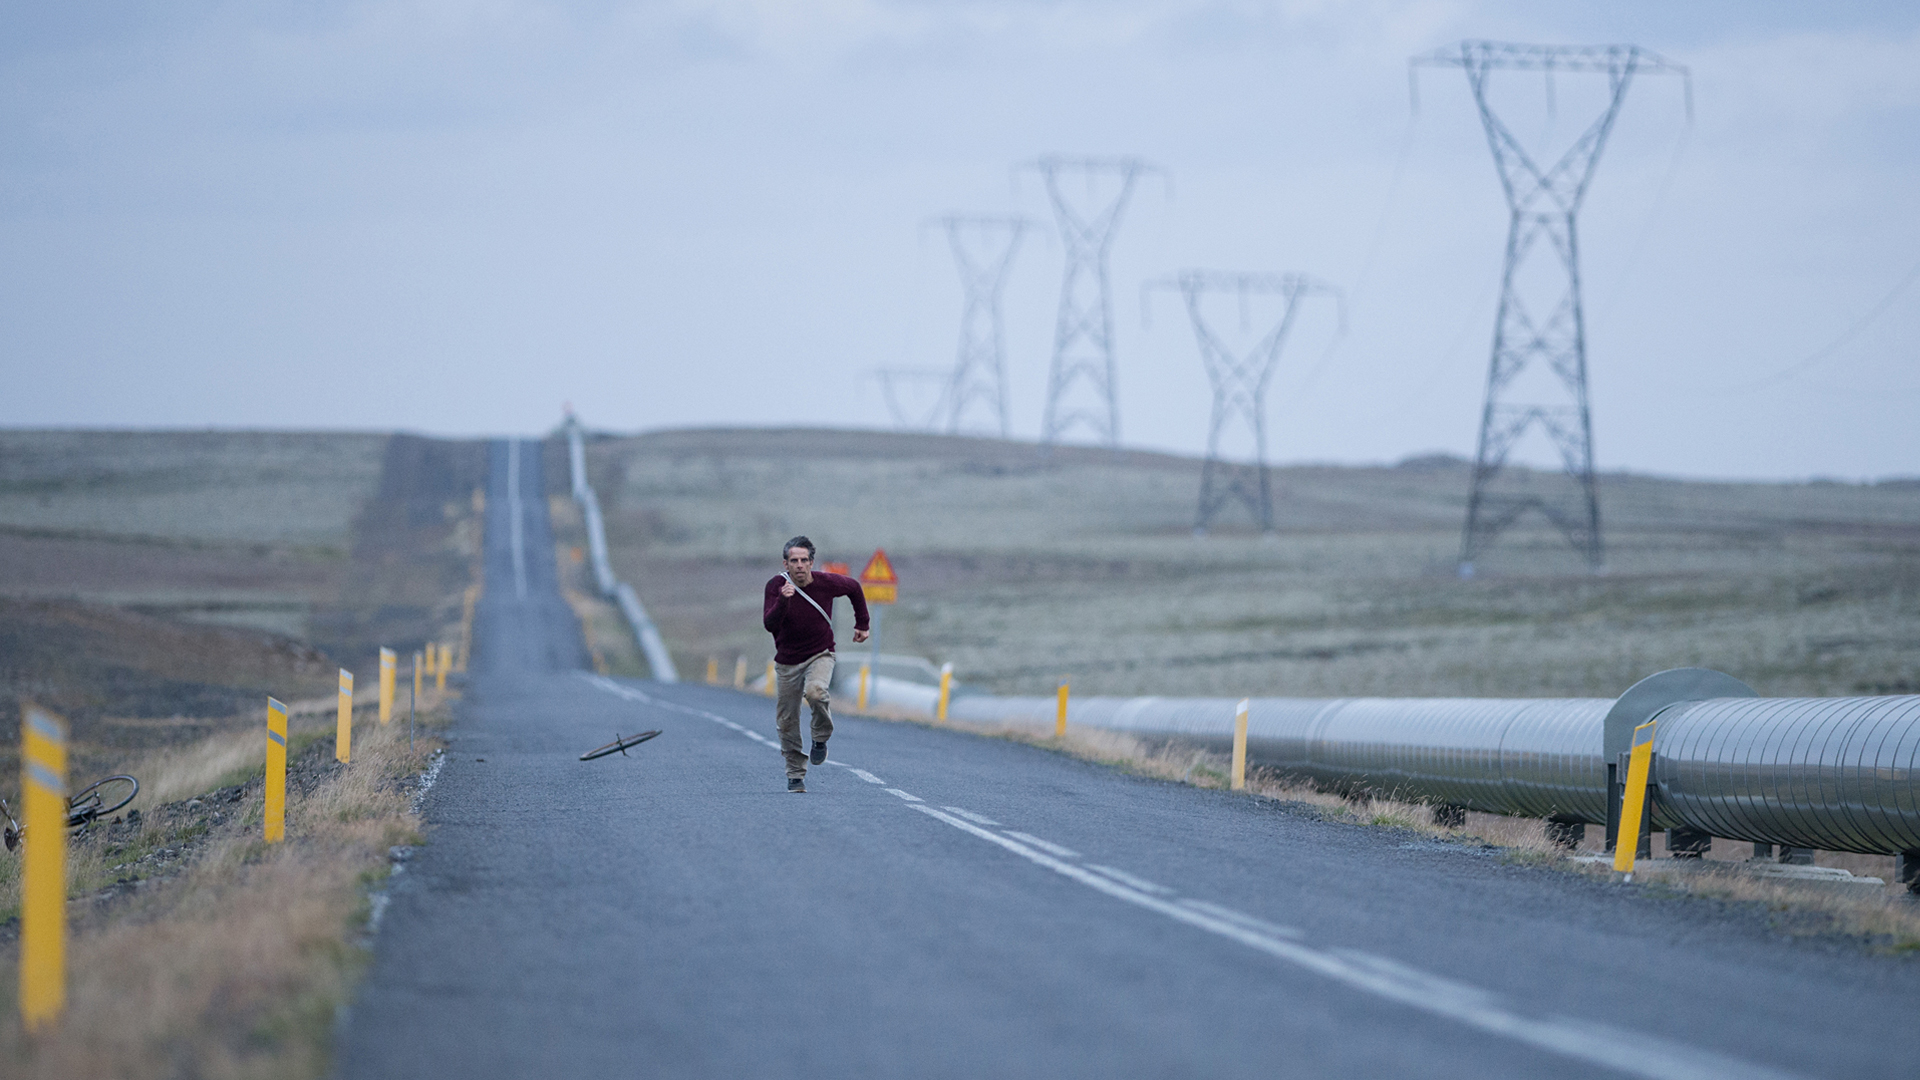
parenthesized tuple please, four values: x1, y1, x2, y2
(0, 0, 1920, 479)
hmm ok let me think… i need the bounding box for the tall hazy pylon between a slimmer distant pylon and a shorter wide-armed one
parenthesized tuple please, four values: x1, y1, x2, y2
(1027, 154, 1162, 450)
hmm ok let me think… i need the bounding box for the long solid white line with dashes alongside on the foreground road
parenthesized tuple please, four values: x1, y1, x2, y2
(912, 803, 1793, 1080)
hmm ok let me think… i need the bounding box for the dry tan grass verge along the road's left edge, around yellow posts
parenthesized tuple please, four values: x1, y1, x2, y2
(0, 701, 447, 1080)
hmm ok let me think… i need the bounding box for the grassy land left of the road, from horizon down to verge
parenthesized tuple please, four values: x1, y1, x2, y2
(0, 424, 486, 1076)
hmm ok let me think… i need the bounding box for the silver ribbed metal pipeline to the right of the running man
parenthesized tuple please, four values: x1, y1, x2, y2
(917, 669, 1920, 855)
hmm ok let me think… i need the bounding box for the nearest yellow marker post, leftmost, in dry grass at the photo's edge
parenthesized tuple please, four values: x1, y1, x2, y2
(19, 701, 67, 1032)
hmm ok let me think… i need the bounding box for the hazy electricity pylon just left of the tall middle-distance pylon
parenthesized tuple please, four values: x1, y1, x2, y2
(939, 213, 1031, 438)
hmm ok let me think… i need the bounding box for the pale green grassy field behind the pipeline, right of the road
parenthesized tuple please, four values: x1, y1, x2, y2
(589, 430, 1920, 698)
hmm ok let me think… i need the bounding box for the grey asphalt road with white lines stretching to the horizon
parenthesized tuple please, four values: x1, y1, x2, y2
(338, 438, 1920, 1080)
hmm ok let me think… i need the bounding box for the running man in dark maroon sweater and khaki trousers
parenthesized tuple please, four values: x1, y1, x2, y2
(760, 536, 868, 792)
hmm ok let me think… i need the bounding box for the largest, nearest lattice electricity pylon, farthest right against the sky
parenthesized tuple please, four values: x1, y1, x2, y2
(1411, 40, 1693, 577)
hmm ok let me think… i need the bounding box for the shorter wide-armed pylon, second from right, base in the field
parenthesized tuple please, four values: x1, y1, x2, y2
(1142, 269, 1346, 536)
